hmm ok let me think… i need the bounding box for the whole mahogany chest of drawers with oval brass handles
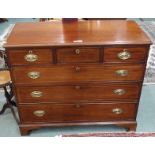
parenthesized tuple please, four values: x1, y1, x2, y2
(5, 20, 151, 135)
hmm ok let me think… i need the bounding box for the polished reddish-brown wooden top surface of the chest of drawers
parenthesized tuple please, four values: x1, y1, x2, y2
(4, 20, 151, 48)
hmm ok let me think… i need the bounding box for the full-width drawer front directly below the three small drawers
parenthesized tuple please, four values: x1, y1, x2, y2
(12, 64, 144, 84)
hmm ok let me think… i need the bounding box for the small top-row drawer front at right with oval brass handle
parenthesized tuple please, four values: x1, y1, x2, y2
(104, 47, 148, 62)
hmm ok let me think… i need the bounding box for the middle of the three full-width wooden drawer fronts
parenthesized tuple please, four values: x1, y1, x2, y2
(16, 83, 140, 104)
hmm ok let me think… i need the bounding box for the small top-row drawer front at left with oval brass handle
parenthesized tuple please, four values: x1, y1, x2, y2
(8, 49, 53, 65)
